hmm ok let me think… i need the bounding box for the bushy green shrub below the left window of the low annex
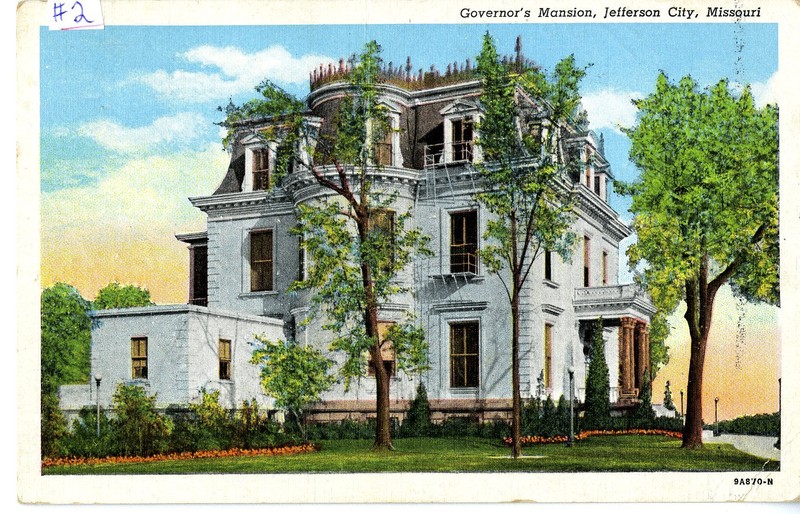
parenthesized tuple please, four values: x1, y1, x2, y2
(113, 384, 173, 456)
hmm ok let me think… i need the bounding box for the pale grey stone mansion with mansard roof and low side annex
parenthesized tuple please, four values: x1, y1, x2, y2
(61, 50, 654, 420)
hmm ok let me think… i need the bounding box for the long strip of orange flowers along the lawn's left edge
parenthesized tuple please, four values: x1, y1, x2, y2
(42, 443, 319, 468)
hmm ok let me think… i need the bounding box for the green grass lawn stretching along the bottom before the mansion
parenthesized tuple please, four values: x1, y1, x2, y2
(44, 435, 779, 475)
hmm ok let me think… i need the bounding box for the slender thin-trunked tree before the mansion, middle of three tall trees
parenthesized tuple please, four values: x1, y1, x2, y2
(476, 33, 585, 458)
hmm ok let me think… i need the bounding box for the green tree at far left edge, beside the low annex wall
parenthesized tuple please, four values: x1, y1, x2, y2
(41, 283, 91, 394)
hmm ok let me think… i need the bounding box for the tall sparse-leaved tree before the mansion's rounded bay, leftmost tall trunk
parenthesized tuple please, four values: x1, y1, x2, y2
(223, 41, 428, 449)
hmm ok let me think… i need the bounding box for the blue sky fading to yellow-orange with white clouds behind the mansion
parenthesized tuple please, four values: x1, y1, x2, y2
(40, 23, 780, 420)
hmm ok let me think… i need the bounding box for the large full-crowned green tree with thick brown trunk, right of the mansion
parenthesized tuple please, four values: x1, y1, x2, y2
(620, 73, 779, 448)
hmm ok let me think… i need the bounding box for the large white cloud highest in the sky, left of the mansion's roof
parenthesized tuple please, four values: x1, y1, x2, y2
(135, 45, 333, 102)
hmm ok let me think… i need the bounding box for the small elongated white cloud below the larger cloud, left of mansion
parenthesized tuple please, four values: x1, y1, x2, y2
(78, 112, 207, 153)
